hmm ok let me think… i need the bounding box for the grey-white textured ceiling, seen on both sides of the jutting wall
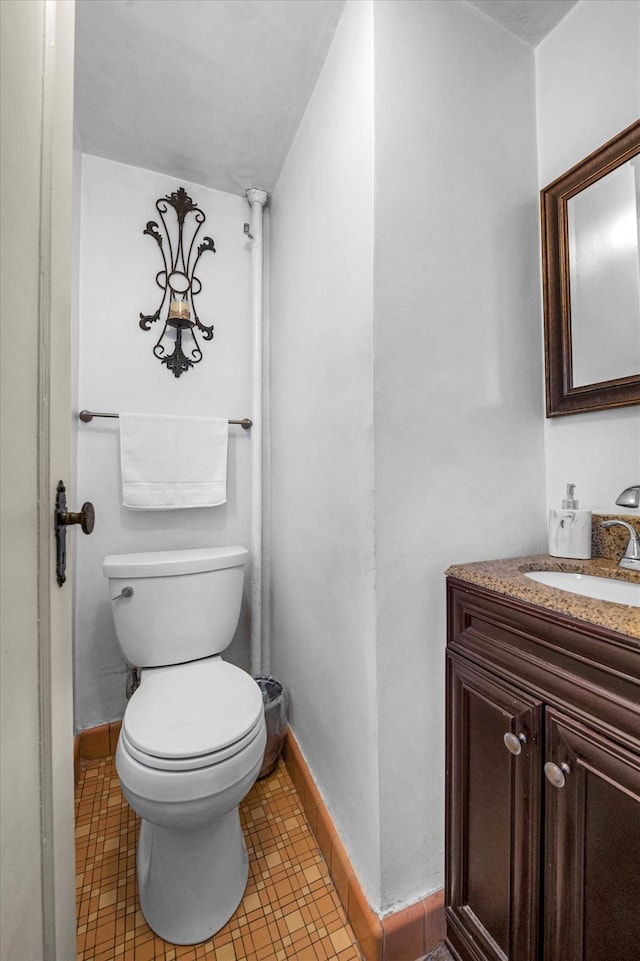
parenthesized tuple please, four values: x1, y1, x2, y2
(75, 0, 574, 195)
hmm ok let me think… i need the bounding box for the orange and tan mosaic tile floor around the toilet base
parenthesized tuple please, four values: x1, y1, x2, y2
(76, 758, 362, 961)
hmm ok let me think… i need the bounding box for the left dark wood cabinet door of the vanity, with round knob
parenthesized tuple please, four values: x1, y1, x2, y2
(446, 653, 542, 961)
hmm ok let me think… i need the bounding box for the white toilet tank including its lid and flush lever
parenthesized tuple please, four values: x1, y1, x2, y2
(102, 547, 249, 667)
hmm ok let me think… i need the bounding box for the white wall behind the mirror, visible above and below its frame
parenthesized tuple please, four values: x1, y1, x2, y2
(536, 0, 640, 513)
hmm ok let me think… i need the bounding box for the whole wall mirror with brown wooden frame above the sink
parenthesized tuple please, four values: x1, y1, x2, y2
(540, 121, 640, 417)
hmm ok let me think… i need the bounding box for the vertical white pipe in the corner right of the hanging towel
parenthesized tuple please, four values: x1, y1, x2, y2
(246, 187, 268, 674)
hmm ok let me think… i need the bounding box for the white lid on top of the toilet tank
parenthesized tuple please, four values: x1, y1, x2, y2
(102, 547, 249, 578)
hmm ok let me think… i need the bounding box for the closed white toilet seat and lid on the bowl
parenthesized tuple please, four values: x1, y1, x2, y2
(121, 655, 264, 771)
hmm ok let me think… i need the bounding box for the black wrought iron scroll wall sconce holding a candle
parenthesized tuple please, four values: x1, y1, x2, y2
(140, 187, 216, 377)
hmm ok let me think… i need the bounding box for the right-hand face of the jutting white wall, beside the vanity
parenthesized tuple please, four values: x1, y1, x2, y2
(374, 0, 546, 909)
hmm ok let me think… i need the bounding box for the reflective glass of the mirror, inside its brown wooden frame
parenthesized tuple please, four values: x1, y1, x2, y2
(567, 157, 640, 387)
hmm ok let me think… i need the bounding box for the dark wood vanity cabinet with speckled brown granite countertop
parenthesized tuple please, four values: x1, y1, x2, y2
(446, 557, 640, 961)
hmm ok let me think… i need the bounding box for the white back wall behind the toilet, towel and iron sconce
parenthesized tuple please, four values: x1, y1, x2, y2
(75, 155, 251, 730)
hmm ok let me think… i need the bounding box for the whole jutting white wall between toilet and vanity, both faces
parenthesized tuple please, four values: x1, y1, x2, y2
(271, 0, 546, 913)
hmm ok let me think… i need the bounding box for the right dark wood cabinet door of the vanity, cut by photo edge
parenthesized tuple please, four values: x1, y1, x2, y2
(544, 708, 640, 961)
